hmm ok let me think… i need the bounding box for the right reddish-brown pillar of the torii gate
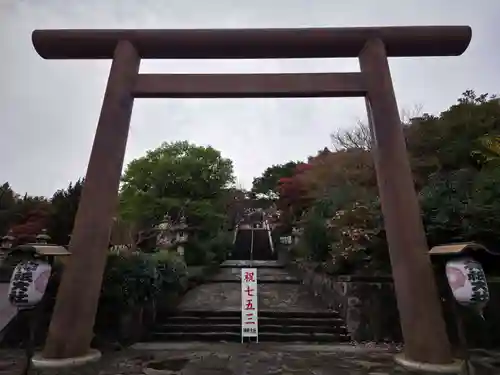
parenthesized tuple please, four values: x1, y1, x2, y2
(359, 39, 453, 364)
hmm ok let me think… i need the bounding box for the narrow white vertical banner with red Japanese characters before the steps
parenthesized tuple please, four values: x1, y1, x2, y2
(241, 268, 259, 339)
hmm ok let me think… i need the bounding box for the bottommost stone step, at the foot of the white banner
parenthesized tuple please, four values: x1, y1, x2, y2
(149, 332, 350, 343)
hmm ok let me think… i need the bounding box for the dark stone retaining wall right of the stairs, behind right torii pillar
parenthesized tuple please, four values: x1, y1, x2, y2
(281, 255, 500, 348)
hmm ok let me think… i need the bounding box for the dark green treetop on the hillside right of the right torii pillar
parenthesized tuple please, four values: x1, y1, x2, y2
(405, 90, 500, 181)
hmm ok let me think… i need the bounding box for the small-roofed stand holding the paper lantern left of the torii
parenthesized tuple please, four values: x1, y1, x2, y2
(7, 242, 70, 375)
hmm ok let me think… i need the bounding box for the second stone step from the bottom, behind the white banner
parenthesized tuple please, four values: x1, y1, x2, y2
(155, 321, 347, 334)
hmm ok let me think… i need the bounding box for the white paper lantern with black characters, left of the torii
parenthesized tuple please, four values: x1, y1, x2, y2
(8, 260, 52, 309)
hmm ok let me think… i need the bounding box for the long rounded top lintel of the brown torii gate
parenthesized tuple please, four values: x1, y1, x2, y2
(32, 26, 472, 59)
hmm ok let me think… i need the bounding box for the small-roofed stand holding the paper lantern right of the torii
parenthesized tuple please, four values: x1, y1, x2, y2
(429, 242, 498, 375)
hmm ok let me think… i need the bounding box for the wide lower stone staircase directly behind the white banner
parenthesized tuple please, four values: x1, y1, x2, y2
(148, 260, 350, 343)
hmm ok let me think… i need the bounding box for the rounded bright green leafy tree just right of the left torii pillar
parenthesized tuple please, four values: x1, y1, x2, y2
(120, 141, 234, 232)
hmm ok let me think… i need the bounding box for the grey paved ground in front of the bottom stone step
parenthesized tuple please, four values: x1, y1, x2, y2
(0, 343, 500, 375)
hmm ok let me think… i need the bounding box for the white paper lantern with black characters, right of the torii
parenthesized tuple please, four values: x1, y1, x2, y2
(446, 258, 490, 313)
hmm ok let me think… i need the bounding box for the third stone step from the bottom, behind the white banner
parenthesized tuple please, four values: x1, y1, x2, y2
(159, 315, 344, 327)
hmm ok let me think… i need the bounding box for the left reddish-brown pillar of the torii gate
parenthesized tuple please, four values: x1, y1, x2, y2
(43, 41, 140, 358)
